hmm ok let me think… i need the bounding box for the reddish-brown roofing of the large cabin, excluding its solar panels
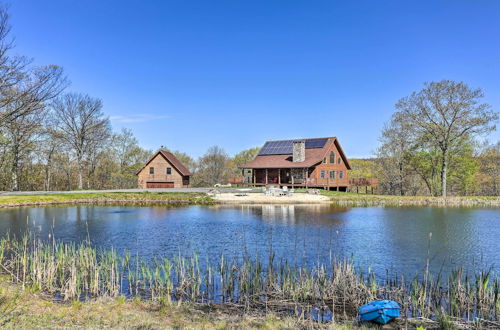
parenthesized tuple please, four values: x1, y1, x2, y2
(240, 137, 351, 170)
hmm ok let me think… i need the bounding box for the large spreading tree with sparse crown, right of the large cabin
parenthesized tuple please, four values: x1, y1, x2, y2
(396, 80, 498, 197)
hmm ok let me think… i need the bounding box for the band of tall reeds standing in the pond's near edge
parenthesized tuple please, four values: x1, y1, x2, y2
(0, 234, 500, 322)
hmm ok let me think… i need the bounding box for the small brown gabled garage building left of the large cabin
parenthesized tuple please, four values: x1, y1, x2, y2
(136, 150, 191, 189)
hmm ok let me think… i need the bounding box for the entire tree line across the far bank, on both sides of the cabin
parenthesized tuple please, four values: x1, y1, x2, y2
(0, 7, 500, 196)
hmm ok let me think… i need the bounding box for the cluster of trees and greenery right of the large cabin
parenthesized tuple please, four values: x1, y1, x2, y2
(351, 80, 500, 197)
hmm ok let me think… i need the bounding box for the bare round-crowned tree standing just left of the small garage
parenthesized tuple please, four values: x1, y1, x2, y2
(52, 93, 111, 189)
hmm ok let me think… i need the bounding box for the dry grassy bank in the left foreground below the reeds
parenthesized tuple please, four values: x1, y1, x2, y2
(0, 276, 364, 329)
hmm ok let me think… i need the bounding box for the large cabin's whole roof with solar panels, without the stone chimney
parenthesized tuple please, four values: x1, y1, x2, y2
(240, 137, 351, 169)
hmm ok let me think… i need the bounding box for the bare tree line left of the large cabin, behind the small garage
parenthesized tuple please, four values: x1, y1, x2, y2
(0, 7, 258, 191)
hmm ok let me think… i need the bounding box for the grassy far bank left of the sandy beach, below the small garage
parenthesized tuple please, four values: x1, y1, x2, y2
(0, 192, 212, 207)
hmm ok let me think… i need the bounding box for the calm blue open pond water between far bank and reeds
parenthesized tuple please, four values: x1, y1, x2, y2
(0, 205, 500, 277)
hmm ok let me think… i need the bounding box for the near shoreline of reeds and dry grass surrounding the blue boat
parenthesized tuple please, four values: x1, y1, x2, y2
(0, 234, 499, 329)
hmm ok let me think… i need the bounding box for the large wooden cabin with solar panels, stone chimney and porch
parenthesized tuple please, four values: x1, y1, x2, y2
(240, 137, 351, 191)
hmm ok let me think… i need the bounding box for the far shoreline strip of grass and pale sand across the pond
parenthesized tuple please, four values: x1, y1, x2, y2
(0, 191, 500, 208)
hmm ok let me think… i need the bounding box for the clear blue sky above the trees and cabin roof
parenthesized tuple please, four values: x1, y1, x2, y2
(10, 0, 500, 157)
